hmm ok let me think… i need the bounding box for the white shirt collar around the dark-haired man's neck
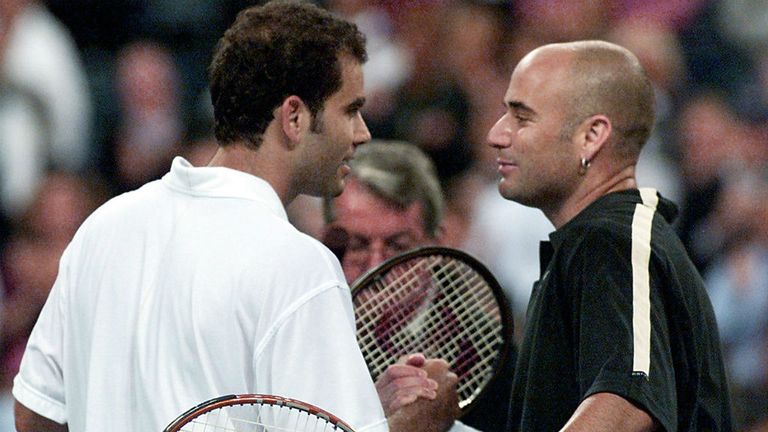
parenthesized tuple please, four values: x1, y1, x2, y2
(162, 156, 288, 220)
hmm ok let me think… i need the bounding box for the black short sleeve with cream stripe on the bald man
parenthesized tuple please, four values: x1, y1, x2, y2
(569, 230, 677, 430)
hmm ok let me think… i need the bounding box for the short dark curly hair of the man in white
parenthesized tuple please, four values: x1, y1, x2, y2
(209, 0, 368, 148)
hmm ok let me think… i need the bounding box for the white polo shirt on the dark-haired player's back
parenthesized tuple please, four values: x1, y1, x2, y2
(13, 158, 387, 432)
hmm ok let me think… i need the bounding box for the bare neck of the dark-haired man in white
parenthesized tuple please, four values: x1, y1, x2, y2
(208, 142, 296, 207)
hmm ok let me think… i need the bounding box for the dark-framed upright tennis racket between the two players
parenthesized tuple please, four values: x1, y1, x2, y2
(352, 247, 514, 414)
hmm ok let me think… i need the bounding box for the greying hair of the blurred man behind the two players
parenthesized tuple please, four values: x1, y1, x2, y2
(323, 140, 445, 237)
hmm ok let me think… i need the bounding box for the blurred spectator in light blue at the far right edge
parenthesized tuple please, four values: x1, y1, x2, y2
(705, 168, 768, 430)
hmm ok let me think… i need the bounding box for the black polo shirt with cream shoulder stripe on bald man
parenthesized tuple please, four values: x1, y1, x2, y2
(508, 189, 731, 432)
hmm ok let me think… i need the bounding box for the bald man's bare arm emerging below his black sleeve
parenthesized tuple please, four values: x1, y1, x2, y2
(561, 393, 657, 432)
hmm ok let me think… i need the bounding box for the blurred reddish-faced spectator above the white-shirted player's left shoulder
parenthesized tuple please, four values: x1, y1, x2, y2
(103, 41, 184, 192)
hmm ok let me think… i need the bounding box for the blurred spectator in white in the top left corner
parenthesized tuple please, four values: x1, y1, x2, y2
(0, 0, 93, 171)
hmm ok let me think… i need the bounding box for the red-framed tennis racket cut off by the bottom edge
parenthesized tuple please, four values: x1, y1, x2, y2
(163, 394, 354, 432)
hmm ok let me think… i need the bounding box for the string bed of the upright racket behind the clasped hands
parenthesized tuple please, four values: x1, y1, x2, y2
(356, 256, 504, 403)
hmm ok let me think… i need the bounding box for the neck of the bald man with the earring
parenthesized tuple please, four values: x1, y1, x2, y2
(542, 165, 637, 229)
